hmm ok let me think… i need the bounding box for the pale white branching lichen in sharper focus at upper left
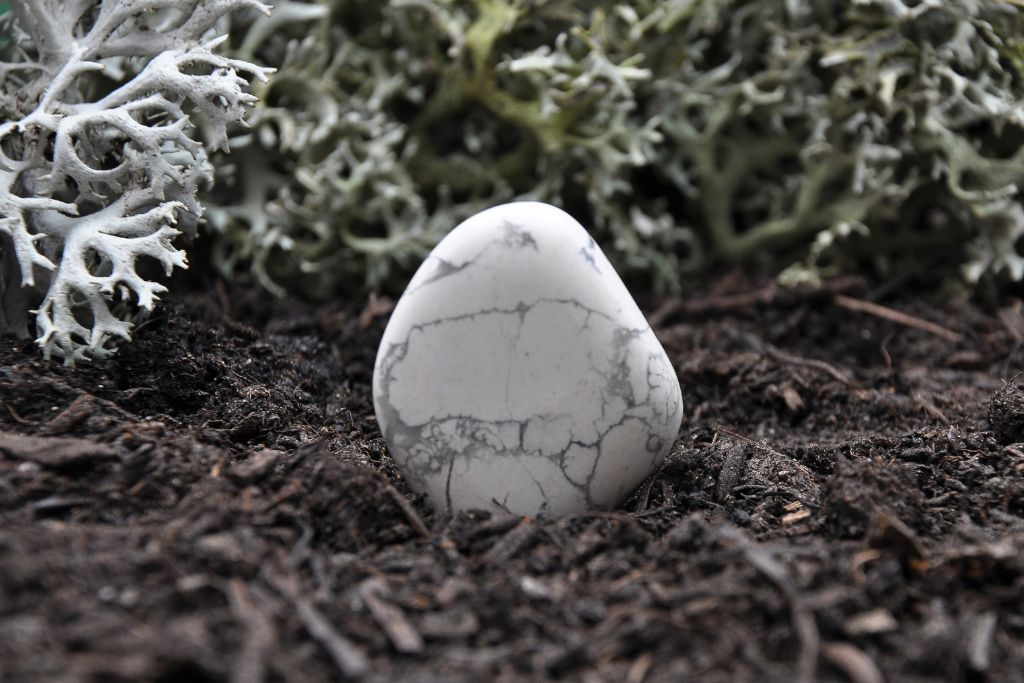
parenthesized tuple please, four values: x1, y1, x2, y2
(0, 0, 270, 364)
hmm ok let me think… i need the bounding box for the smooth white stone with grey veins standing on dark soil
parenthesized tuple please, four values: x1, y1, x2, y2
(374, 202, 683, 515)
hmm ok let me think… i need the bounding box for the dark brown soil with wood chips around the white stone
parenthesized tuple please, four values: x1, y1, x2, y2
(0, 279, 1024, 683)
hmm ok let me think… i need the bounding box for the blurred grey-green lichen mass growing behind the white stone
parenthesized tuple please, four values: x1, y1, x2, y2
(205, 0, 1024, 298)
